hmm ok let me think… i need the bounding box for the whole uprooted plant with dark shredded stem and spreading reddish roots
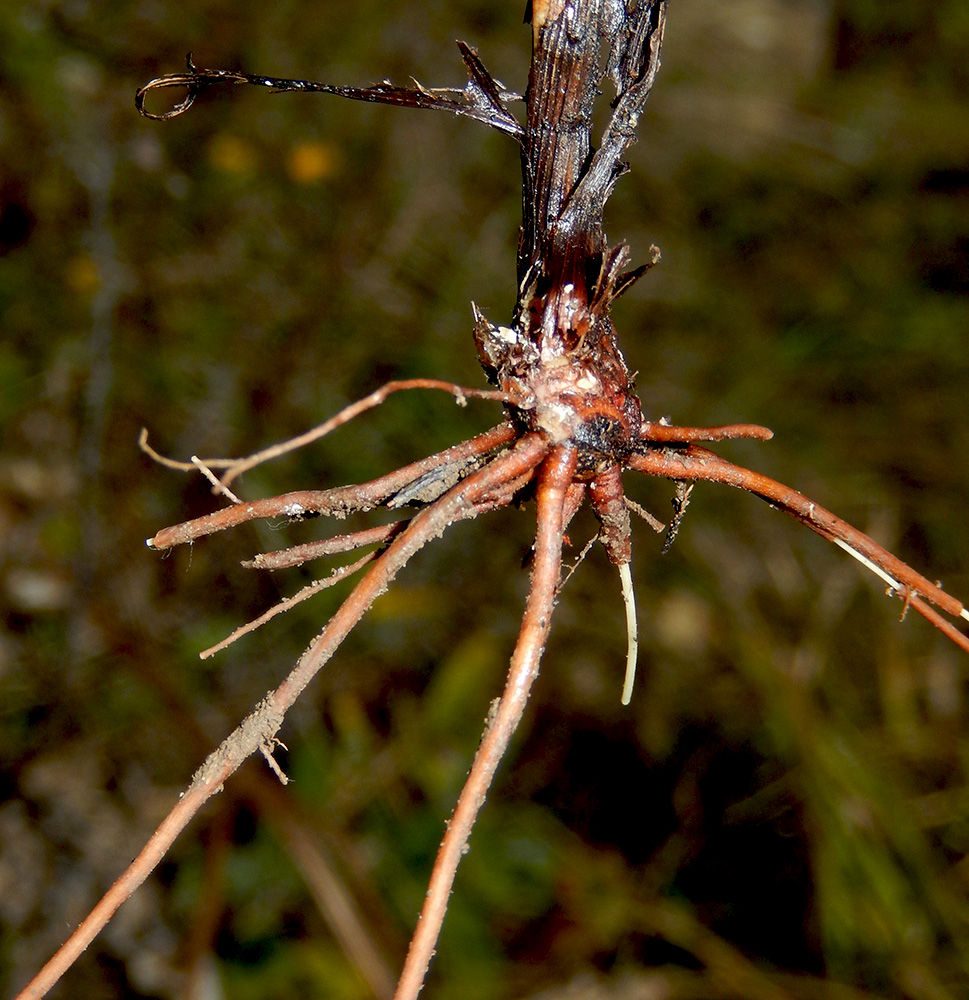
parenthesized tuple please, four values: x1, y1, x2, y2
(19, 0, 969, 1000)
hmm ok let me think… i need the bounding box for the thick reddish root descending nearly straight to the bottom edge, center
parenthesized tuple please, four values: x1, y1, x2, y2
(394, 446, 576, 1000)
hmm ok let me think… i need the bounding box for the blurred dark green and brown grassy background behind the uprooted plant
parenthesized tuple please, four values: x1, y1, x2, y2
(0, 0, 969, 1000)
